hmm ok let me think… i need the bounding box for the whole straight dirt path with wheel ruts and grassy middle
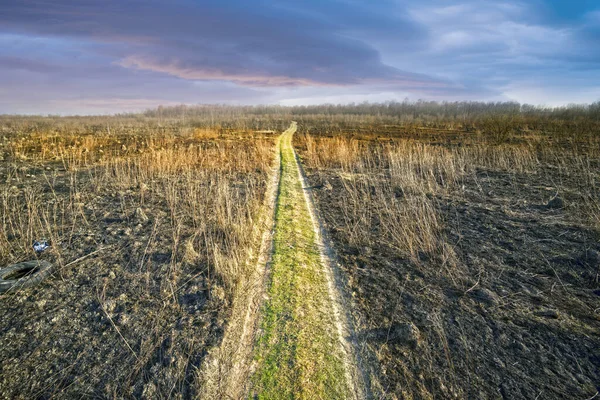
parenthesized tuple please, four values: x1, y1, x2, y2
(200, 122, 368, 399)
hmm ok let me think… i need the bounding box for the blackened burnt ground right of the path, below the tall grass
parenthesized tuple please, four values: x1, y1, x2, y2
(300, 153, 600, 399)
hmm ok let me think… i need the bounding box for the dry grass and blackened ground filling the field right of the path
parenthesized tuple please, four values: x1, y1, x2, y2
(297, 127, 600, 398)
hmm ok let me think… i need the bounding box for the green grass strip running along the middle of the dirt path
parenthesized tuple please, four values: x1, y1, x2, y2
(250, 122, 356, 399)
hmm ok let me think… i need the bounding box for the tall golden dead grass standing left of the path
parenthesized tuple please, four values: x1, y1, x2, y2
(0, 129, 273, 290)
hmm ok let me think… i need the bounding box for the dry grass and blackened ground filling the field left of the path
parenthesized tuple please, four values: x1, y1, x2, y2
(0, 124, 274, 397)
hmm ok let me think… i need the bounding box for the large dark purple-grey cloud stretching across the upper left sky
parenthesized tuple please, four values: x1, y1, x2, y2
(0, 0, 446, 90)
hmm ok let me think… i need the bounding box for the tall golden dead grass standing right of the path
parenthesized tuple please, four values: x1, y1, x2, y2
(299, 135, 600, 265)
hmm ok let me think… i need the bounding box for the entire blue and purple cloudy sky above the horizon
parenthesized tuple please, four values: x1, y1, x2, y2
(0, 0, 600, 114)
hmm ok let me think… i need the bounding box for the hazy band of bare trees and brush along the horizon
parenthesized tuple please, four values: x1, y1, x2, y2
(0, 101, 600, 142)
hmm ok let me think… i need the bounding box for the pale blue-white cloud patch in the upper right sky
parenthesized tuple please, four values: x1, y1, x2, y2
(386, 0, 600, 103)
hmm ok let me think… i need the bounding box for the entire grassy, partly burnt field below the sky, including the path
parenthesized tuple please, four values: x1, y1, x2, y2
(0, 103, 600, 399)
